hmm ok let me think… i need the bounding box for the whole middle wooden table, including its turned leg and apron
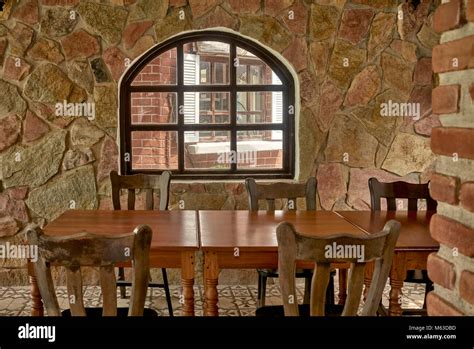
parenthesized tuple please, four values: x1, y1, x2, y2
(199, 211, 367, 316)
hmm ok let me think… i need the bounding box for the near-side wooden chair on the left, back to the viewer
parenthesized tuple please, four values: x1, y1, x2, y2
(26, 225, 158, 316)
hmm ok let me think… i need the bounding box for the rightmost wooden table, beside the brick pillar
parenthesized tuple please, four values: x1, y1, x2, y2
(337, 211, 439, 315)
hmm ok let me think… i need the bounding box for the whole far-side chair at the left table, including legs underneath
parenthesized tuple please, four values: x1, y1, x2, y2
(110, 171, 173, 316)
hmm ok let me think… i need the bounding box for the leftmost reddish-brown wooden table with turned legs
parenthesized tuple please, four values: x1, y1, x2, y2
(28, 210, 199, 316)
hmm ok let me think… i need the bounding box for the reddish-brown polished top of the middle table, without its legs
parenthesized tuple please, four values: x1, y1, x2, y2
(199, 211, 367, 251)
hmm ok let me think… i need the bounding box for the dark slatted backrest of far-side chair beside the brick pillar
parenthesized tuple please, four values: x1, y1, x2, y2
(369, 177, 437, 211)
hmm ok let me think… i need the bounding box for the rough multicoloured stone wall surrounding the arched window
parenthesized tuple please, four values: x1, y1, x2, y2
(0, 0, 439, 284)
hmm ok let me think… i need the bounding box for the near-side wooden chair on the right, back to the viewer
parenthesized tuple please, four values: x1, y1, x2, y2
(257, 220, 400, 316)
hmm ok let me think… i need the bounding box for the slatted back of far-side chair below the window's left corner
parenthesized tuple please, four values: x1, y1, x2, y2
(110, 171, 171, 211)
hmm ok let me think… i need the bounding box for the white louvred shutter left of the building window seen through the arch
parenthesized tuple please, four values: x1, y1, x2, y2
(183, 53, 199, 143)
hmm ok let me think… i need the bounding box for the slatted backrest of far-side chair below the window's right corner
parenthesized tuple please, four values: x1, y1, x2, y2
(245, 177, 317, 211)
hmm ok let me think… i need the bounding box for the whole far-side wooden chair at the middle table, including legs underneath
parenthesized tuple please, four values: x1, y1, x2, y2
(245, 177, 334, 307)
